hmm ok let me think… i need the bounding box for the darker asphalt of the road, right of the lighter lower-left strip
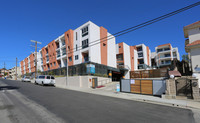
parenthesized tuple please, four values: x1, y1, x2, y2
(0, 79, 194, 123)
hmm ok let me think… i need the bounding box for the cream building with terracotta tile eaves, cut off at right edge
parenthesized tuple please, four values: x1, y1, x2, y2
(183, 21, 200, 88)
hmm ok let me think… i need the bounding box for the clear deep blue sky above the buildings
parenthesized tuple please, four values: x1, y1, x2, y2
(0, 0, 200, 69)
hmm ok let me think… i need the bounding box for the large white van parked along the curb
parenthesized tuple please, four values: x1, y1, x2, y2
(35, 75, 56, 85)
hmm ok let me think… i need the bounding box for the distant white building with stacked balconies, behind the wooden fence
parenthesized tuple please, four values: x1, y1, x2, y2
(151, 43, 180, 67)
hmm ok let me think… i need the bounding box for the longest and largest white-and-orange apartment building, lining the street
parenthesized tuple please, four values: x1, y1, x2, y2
(20, 21, 120, 79)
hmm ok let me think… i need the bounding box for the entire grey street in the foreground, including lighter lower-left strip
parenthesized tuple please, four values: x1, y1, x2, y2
(0, 79, 194, 123)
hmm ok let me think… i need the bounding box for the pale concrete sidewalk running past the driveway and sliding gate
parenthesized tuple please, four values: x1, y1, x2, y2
(62, 83, 200, 109)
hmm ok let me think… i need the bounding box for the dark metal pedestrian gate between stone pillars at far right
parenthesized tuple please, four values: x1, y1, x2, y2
(175, 77, 192, 98)
